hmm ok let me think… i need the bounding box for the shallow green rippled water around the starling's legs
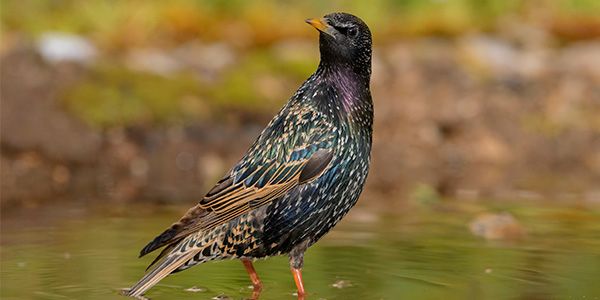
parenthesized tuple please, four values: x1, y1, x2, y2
(0, 199, 600, 299)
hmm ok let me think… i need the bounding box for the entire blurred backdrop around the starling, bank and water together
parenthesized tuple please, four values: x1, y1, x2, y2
(0, 0, 600, 299)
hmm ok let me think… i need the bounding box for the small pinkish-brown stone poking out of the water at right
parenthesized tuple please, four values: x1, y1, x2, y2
(469, 212, 526, 240)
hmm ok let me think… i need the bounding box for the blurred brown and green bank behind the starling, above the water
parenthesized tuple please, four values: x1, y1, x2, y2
(1, 0, 600, 207)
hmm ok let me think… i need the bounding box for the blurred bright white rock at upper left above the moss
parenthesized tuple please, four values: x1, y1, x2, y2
(38, 32, 98, 64)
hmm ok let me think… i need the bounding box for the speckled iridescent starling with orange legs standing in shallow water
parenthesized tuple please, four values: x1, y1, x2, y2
(124, 12, 373, 297)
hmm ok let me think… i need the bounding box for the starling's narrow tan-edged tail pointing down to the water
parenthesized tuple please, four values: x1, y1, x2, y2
(123, 247, 201, 297)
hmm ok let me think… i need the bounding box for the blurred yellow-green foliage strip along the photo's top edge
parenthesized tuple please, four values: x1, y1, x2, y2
(1, 0, 600, 49)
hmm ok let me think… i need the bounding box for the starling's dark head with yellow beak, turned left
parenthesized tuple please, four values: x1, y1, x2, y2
(306, 13, 371, 75)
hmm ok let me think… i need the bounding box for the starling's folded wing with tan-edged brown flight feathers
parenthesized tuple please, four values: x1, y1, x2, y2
(140, 106, 333, 258)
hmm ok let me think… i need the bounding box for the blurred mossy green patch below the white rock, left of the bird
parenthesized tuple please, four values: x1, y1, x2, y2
(64, 66, 199, 127)
